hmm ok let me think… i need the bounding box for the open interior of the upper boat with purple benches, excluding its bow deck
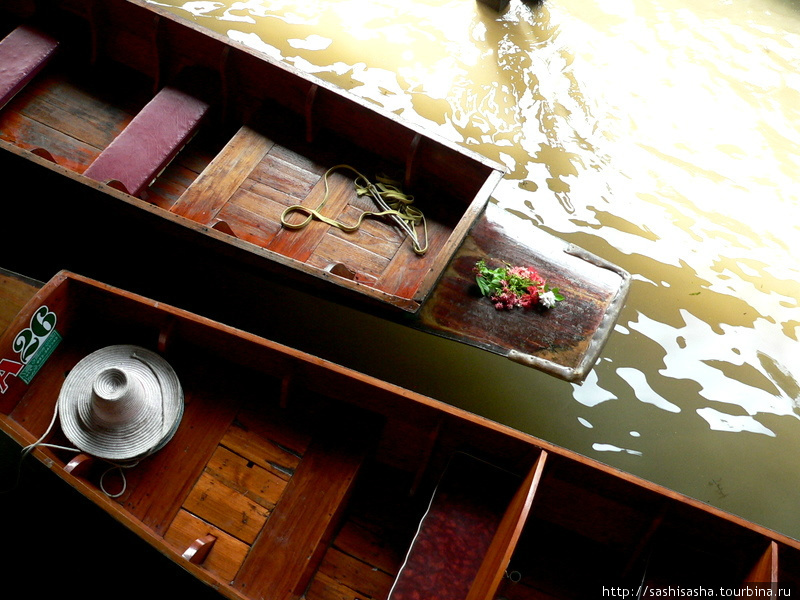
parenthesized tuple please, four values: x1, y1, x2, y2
(0, 0, 503, 312)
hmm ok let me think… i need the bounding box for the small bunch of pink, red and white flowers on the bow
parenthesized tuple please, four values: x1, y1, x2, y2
(474, 260, 564, 310)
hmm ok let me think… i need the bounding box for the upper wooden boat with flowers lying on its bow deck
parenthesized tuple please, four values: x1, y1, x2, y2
(0, 0, 629, 381)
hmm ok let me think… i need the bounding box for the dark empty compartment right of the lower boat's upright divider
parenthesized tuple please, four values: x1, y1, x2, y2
(498, 454, 793, 600)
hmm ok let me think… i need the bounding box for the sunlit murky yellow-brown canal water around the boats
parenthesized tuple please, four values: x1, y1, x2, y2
(150, 0, 800, 538)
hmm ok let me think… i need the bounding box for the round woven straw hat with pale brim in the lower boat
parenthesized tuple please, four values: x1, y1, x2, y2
(58, 345, 183, 462)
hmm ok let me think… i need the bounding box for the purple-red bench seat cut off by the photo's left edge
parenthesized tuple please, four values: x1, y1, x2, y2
(0, 25, 58, 108)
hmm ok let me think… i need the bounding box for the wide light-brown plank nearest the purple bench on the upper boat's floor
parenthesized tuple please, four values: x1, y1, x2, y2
(172, 126, 273, 223)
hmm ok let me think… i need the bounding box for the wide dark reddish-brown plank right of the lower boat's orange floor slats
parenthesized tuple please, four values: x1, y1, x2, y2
(232, 423, 366, 600)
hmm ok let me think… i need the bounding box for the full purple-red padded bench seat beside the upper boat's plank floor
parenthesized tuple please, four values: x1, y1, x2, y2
(84, 86, 210, 198)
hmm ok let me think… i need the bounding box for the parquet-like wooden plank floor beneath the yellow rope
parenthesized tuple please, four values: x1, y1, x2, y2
(172, 108, 462, 298)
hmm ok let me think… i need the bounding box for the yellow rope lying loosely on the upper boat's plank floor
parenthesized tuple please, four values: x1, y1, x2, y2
(281, 165, 428, 255)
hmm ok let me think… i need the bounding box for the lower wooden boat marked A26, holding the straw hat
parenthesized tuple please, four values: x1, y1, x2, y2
(0, 272, 800, 600)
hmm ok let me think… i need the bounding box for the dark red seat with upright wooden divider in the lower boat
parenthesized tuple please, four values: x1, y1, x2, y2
(389, 452, 546, 600)
